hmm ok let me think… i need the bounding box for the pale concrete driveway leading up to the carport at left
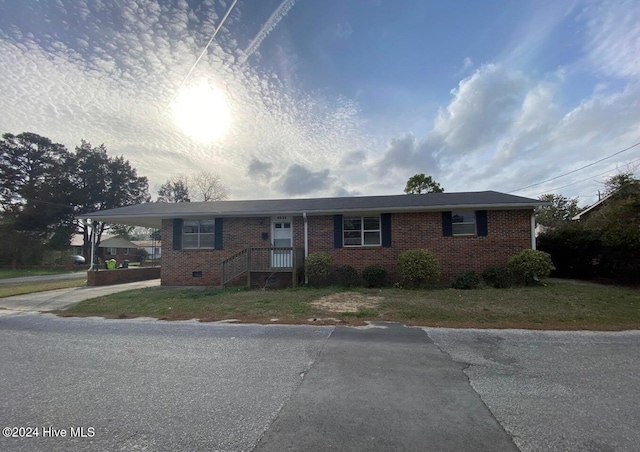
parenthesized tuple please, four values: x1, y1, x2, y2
(0, 279, 160, 315)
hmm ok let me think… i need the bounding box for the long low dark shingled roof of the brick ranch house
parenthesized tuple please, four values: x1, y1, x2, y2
(81, 191, 544, 228)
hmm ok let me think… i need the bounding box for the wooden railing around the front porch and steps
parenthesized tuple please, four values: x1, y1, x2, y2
(220, 247, 304, 287)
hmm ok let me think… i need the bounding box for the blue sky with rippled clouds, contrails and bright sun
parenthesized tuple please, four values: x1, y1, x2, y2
(0, 0, 640, 205)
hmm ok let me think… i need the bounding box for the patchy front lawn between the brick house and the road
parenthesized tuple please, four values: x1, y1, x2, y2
(58, 279, 640, 330)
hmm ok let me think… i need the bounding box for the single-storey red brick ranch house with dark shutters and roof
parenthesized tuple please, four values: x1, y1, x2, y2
(85, 191, 544, 286)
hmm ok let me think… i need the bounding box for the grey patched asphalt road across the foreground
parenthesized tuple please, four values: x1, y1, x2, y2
(0, 313, 640, 451)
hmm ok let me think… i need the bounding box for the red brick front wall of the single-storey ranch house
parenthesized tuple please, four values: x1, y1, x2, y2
(162, 210, 532, 286)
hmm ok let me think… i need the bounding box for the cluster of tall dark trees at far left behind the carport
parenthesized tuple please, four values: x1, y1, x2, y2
(0, 132, 149, 263)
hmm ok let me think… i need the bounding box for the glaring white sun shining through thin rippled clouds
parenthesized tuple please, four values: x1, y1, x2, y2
(173, 83, 231, 143)
